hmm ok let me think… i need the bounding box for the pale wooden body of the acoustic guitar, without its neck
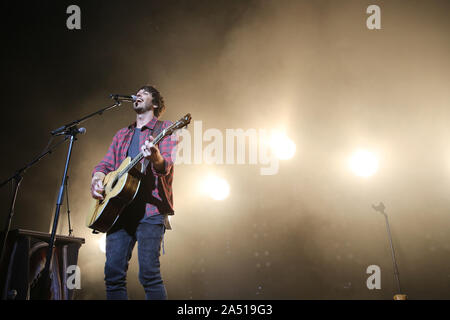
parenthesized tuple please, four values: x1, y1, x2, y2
(86, 157, 142, 232)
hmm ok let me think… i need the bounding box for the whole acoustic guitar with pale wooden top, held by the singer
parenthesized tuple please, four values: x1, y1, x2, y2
(86, 113, 191, 233)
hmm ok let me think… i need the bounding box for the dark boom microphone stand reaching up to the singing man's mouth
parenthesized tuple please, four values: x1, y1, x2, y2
(36, 98, 121, 300)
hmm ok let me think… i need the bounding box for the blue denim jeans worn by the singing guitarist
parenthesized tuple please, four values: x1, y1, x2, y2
(105, 223, 167, 300)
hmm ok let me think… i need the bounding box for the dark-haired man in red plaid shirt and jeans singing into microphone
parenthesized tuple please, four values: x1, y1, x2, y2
(91, 86, 177, 299)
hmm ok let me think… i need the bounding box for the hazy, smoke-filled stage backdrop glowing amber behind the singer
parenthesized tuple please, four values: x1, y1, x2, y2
(0, 0, 450, 299)
